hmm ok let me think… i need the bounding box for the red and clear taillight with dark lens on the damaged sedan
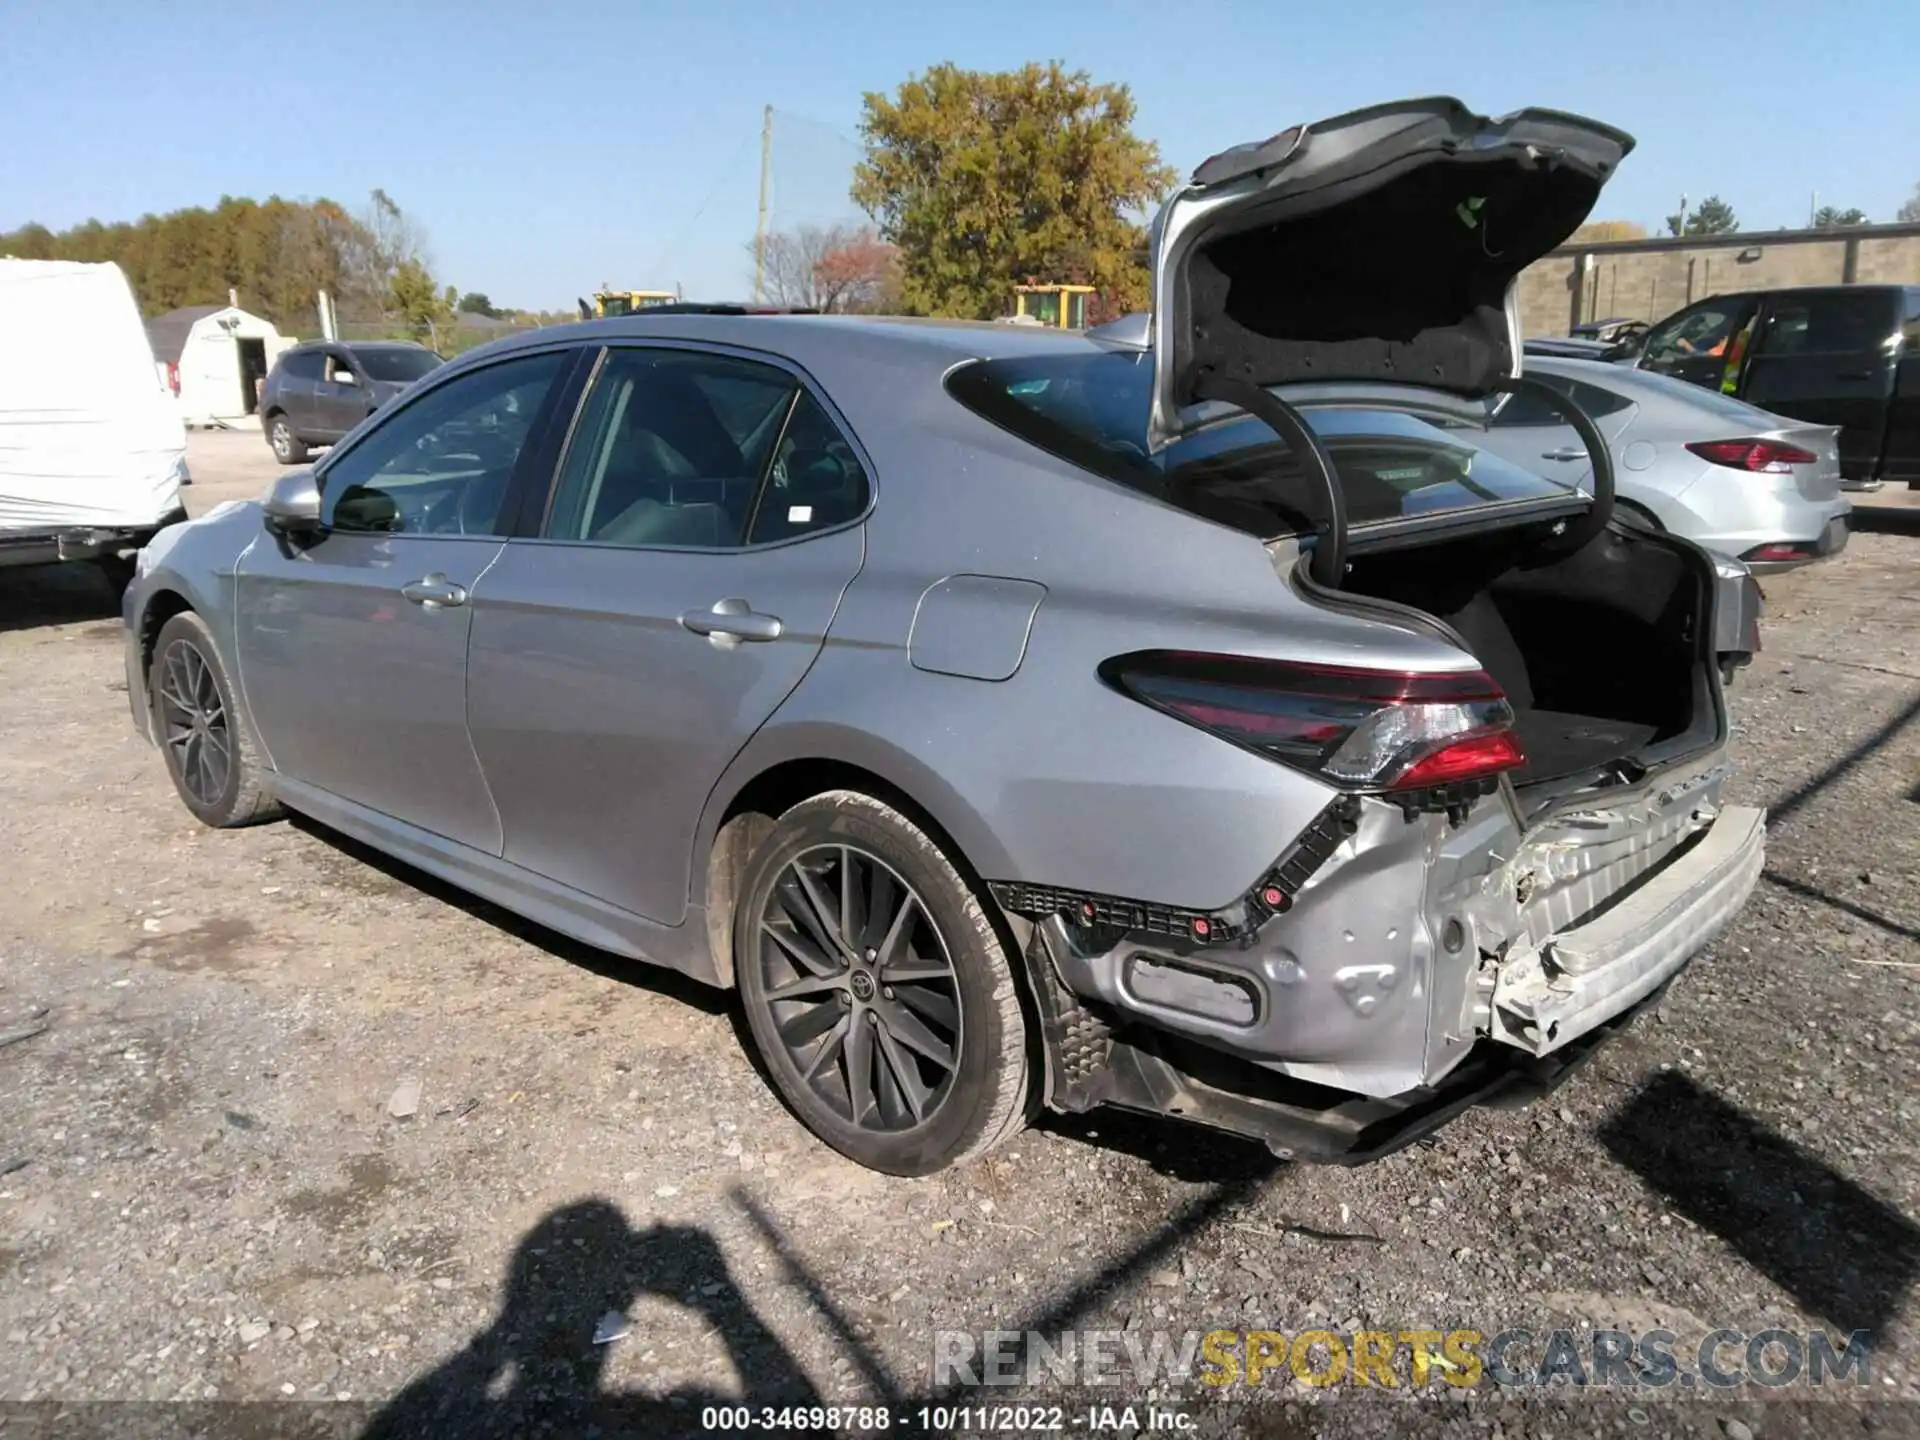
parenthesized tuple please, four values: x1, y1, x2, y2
(1102, 651, 1526, 791)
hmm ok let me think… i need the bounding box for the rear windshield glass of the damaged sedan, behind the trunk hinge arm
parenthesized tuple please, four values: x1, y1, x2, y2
(947, 351, 1571, 540)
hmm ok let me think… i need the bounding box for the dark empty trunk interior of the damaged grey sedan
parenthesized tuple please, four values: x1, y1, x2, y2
(1342, 530, 1720, 791)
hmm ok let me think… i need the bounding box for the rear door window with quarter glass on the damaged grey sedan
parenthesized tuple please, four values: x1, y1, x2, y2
(545, 348, 866, 549)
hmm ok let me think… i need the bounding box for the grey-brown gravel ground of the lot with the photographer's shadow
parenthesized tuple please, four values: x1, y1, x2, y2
(0, 436, 1920, 1440)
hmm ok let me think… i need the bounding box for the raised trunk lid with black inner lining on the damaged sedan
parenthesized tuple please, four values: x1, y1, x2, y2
(1150, 98, 1634, 449)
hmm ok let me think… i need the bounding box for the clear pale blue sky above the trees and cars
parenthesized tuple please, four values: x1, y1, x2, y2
(0, 0, 1920, 307)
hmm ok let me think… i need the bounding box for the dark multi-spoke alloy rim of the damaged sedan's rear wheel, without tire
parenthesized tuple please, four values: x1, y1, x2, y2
(758, 845, 966, 1133)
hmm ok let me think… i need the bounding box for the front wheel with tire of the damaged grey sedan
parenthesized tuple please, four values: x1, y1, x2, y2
(146, 611, 280, 829)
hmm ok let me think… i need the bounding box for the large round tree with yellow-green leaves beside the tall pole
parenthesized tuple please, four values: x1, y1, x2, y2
(852, 61, 1175, 319)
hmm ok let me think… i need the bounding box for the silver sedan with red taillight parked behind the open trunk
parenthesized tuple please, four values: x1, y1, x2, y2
(1478, 351, 1853, 574)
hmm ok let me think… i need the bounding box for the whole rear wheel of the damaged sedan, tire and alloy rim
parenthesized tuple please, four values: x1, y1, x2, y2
(733, 791, 1029, 1175)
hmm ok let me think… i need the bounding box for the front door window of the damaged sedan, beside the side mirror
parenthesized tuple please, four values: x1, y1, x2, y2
(319, 351, 566, 536)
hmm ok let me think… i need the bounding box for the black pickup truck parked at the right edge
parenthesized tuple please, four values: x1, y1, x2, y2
(1636, 284, 1920, 490)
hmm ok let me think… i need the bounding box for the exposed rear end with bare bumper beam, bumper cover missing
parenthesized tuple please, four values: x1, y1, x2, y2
(1027, 779, 1764, 1164)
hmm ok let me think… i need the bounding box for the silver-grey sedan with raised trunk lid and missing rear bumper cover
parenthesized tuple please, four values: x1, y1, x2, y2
(125, 100, 1763, 1173)
